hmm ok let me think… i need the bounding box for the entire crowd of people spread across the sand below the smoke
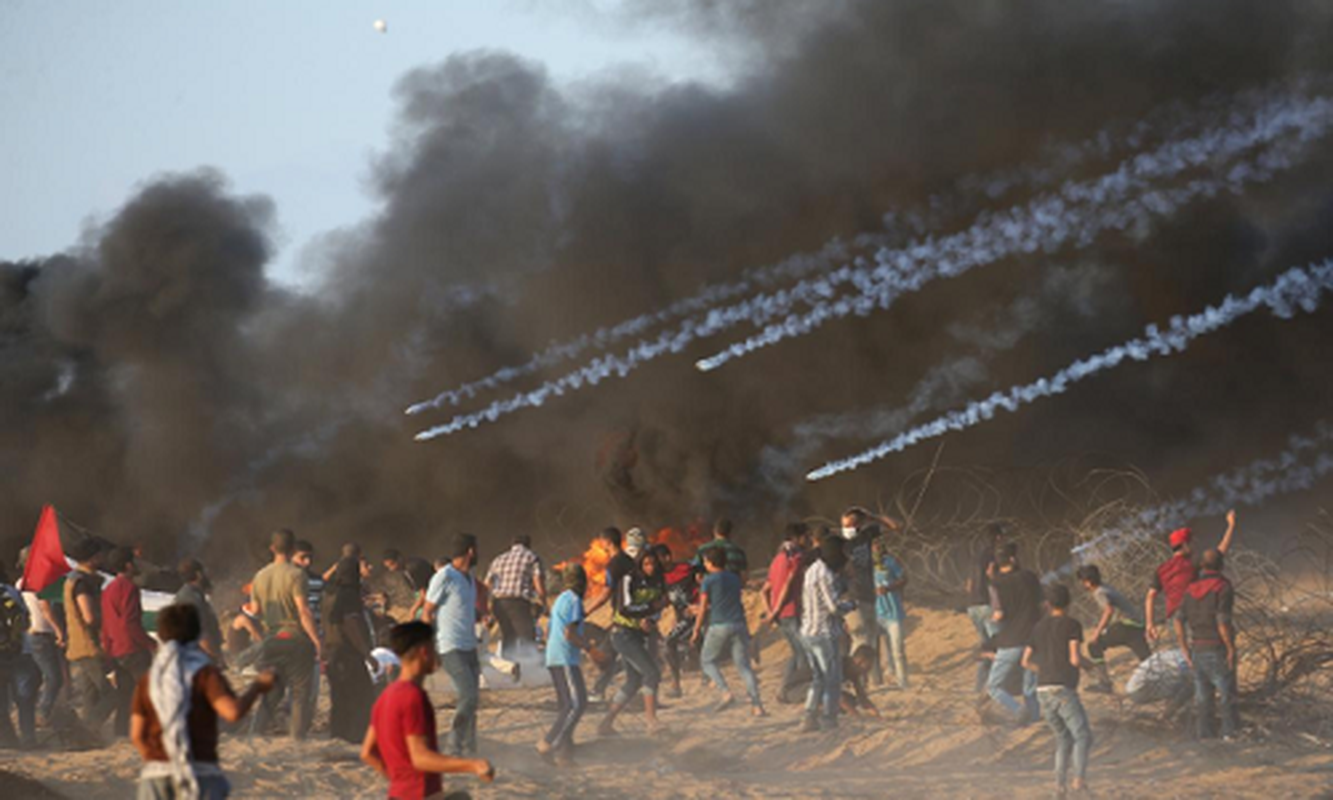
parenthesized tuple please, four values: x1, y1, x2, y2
(0, 507, 1237, 799)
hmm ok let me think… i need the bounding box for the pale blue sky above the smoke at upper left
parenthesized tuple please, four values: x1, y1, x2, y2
(0, 0, 724, 284)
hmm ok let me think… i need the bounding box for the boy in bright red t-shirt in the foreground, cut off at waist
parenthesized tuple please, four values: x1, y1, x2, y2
(361, 623, 496, 800)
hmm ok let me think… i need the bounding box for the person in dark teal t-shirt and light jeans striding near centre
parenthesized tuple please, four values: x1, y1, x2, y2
(692, 548, 768, 716)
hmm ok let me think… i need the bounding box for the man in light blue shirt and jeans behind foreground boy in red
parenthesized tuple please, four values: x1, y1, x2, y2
(421, 533, 481, 756)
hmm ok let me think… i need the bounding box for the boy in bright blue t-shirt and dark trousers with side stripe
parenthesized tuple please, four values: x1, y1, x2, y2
(537, 564, 588, 767)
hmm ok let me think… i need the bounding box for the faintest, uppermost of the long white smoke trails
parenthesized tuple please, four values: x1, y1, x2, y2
(405, 92, 1265, 415)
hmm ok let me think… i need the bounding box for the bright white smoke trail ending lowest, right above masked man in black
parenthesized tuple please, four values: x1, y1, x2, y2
(805, 260, 1333, 481)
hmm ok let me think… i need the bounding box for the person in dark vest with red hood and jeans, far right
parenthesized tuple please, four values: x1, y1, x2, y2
(1173, 549, 1236, 741)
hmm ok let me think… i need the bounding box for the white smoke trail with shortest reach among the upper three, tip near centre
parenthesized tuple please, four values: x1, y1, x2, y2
(694, 96, 1333, 372)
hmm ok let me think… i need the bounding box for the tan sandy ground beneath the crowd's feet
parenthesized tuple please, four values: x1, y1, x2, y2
(0, 609, 1333, 800)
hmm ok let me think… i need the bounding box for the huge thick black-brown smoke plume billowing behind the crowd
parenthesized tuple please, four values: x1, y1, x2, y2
(0, 0, 1333, 565)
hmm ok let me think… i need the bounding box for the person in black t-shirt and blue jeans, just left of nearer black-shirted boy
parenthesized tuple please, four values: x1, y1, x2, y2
(986, 541, 1041, 724)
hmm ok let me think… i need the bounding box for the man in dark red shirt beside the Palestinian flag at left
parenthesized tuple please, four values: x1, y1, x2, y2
(101, 547, 157, 736)
